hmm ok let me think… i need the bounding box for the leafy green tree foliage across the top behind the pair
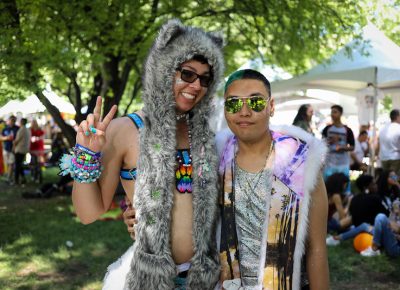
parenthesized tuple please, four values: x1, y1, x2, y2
(0, 0, 365, 144)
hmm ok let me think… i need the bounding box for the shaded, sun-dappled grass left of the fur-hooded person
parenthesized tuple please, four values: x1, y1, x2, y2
(0, 176, 131, 289)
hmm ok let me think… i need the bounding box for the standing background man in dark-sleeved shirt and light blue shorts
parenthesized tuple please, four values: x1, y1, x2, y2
(322, 105, 354, 194)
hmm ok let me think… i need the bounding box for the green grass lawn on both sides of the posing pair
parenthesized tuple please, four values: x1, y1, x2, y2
(0, 169, 400, 290)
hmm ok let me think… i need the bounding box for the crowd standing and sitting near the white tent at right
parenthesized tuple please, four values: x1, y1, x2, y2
(293, 105, 400, 257)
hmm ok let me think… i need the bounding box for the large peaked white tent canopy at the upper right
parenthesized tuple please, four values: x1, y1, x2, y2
(271, 24, 400, 101)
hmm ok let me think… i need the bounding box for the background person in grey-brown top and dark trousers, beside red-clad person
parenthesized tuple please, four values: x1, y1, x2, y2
(13, 118, 31, 185)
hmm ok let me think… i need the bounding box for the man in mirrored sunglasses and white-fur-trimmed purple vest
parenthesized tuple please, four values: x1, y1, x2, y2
(217, 70, 329, 289)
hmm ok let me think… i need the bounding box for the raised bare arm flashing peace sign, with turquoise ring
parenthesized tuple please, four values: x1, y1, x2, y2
(72, 97, 126, 224)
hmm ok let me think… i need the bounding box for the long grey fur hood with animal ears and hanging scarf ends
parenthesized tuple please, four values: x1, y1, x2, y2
(125, 20, 224, 289)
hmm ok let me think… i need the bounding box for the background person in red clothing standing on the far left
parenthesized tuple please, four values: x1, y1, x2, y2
(29, 119, 44, 183)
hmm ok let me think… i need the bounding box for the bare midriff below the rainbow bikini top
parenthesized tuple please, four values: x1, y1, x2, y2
(171, 190, 194, 264)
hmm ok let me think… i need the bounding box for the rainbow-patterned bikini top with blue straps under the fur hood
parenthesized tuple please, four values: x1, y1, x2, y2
(120, 113, 192, 193)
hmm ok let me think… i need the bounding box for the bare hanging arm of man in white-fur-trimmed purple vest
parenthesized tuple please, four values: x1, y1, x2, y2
(306, 176, 329, 290)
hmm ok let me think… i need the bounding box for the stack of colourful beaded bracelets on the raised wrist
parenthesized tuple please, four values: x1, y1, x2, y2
(59, 144, 103, 183)
